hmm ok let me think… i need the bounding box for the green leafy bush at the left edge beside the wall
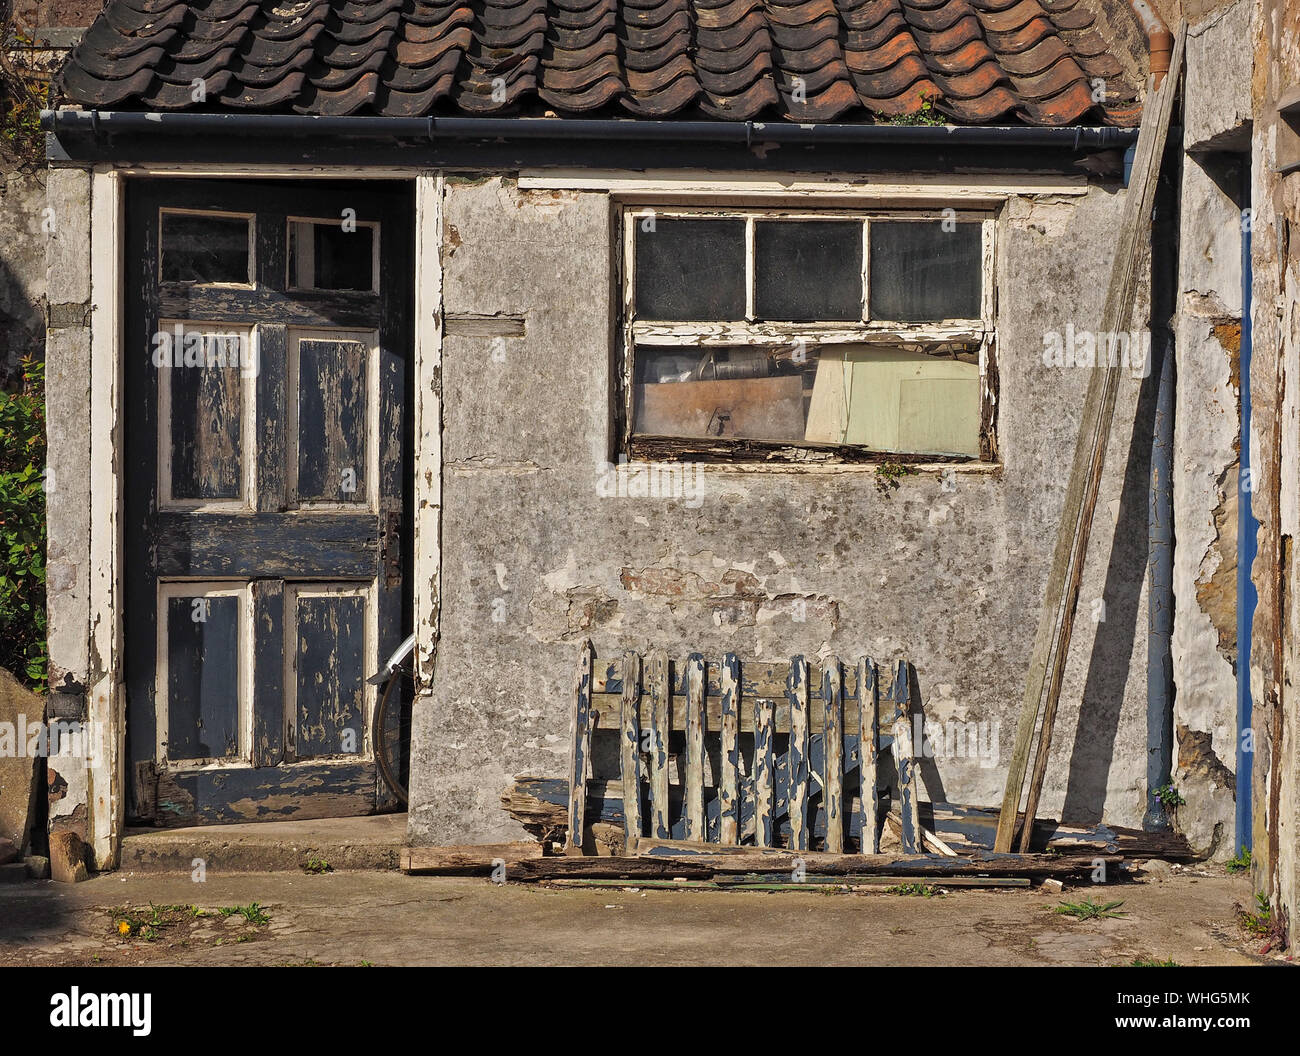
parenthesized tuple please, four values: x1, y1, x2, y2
(0, 359, 49, 688)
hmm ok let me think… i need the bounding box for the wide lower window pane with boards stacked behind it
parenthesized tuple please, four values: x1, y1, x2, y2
(633, 345, 980, 458)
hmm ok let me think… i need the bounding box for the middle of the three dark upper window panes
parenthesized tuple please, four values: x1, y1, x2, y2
(754, 220, 862, 323)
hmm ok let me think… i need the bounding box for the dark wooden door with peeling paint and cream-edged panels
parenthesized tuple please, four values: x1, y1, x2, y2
(125, 181, 413, 825)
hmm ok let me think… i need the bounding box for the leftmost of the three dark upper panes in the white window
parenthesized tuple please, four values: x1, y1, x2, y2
(629, 217, 745, 321)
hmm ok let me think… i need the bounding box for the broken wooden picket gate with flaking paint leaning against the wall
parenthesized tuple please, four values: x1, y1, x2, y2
(566, 641, 922, 853)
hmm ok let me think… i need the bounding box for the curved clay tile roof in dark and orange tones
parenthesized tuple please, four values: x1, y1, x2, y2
(61, 0, 1138, 125)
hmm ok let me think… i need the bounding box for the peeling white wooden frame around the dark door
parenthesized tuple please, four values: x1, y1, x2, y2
(86, 164, 443, 870)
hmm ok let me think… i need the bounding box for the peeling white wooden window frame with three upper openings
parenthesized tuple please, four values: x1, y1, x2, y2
(615, 202, 1000, 464)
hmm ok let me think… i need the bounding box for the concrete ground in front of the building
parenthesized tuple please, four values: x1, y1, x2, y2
(0, 864, 1265, 965)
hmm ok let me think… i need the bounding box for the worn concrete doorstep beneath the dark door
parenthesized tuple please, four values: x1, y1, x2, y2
(120, 814, 407, 873)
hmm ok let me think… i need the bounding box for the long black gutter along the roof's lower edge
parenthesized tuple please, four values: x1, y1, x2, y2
(40, 109, 1138, 151)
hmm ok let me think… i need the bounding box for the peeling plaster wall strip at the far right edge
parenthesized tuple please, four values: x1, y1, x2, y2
(1251, 0, 1300, 948)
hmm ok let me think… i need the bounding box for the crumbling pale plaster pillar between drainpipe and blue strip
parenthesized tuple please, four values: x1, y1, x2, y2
(1173, 0, 1251, 858)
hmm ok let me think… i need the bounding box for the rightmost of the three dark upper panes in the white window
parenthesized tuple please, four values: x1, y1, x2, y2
(870, 220, 982, 323)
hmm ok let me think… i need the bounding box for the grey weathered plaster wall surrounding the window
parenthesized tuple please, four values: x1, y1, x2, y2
(410, 177, 1154, 843)
